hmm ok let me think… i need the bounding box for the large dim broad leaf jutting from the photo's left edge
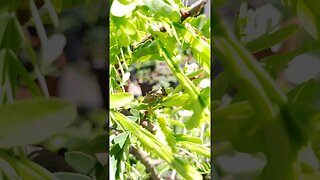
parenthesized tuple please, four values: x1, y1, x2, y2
(0, 98, 77, 148)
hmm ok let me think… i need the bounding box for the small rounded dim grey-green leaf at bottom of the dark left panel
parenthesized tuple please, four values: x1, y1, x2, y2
(65, 151, 97, 174)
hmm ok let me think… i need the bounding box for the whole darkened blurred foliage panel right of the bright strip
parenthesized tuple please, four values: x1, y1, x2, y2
(212, 0, 320, 179)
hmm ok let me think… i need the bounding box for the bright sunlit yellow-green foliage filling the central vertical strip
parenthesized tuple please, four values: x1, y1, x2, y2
(109, 0, 210, 179)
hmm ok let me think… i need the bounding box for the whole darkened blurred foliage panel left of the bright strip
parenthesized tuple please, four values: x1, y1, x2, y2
(0, 0, 108, 179)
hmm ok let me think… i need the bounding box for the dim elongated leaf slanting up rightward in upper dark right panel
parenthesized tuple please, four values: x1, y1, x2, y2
(246, 25, 299, 53)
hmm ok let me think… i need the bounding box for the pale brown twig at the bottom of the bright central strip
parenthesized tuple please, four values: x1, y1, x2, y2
(130, 146, 161, 180)
